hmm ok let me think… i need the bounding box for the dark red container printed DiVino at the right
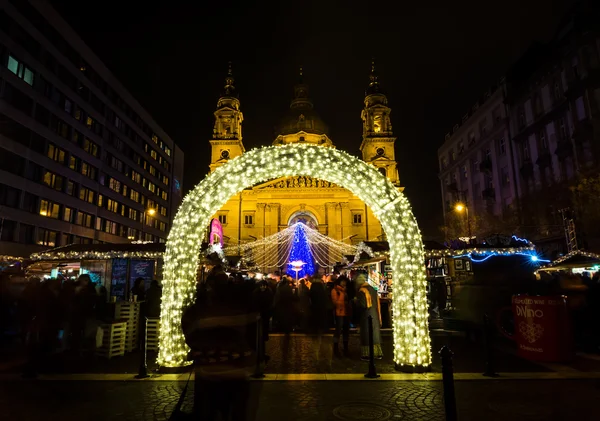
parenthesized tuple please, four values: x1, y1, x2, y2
(512, 295, 573, 362)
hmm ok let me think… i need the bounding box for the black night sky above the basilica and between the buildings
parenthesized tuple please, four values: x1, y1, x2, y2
(53, 0, 573, 237)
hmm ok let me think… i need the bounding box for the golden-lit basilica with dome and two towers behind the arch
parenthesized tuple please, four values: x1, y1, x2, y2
(210, 65, 402, 254)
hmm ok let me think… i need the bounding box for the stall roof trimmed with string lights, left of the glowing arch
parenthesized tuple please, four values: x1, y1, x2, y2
(31, 243, 166, 261)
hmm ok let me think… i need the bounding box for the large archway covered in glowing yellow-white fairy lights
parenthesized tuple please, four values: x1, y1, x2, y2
(158, 144, 431, 368)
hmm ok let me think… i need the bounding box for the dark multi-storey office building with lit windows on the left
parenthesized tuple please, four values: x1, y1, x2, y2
(0, 0, 183, 256)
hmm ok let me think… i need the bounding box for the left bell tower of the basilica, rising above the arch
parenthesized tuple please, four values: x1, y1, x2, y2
(210, 62, 246, 172)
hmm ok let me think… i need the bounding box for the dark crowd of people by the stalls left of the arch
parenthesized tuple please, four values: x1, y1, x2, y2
(0, 274, 161, 376)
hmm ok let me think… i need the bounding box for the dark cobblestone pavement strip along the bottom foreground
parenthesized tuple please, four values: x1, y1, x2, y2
(0, 380, 600, 421)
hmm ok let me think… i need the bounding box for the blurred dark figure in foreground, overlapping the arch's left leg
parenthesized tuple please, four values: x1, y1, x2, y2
(181, 262, 260, 421)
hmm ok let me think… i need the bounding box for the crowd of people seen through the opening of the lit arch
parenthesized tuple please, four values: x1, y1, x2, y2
(186, 265, 383, 360)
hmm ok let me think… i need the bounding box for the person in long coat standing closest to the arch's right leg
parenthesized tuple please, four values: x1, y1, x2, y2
(355, 273, 383, 361)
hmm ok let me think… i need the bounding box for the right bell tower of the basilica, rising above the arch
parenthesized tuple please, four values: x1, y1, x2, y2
(360, 61, 400, 186)
